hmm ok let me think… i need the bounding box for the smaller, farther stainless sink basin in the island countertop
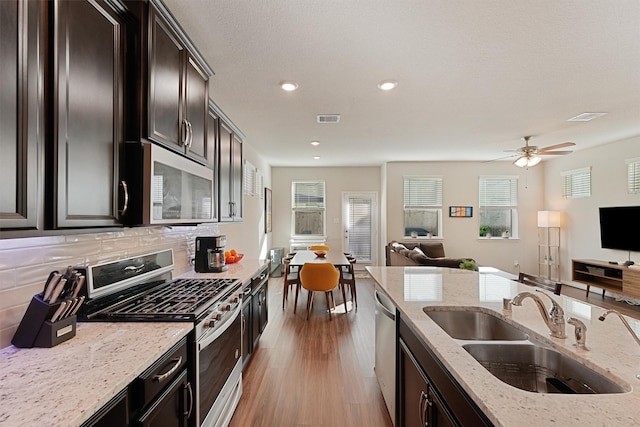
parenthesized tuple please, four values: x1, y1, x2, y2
(422, 307, 529, 341)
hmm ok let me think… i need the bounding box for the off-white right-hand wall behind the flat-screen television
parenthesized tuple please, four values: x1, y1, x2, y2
(544, 136, 640, 280)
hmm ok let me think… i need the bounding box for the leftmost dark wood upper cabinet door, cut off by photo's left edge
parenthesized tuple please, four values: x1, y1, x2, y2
(0, 0, 46, 230)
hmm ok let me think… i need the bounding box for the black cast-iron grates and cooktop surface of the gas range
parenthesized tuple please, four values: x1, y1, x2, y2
(90, 279, 238, 320)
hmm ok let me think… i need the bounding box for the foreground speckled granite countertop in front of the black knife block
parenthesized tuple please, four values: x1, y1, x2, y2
(0, 322, 193, 427)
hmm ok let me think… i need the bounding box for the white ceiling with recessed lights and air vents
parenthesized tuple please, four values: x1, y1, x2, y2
(164, 0, 640, 167)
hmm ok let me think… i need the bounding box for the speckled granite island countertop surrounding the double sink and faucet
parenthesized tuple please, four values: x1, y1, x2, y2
(367, 267, 640, 426)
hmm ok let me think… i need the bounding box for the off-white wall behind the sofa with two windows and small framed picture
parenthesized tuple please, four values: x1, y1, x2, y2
(386, 162, 544, 274)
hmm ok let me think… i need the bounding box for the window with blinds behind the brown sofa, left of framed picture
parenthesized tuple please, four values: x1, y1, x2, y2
(404, 176, 442, 237)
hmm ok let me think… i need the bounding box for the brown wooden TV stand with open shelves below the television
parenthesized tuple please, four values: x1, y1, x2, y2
(571, 259, 640, 298)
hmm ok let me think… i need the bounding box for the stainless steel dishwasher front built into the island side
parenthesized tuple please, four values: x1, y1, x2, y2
(374, 286, 396, 425)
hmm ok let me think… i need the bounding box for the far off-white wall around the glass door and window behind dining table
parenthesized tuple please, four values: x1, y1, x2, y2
(271, 167, 383, 259)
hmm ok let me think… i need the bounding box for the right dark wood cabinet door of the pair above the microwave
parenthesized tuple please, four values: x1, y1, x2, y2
(184, 56, 215, 165)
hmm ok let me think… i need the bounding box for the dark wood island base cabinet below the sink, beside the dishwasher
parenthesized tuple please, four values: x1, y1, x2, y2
(396, 317, 493, 427)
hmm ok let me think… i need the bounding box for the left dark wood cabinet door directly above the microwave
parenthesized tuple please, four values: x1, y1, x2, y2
(148, 8, 182, 151)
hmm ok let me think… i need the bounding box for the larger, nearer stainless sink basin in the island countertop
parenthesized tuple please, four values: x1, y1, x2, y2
(462, 343, 630, 394)
